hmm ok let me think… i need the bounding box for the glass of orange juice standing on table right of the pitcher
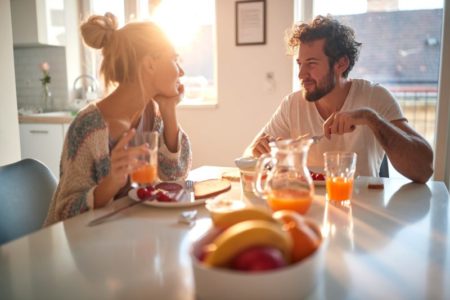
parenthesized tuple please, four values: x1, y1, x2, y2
(323, 151, 357, 202)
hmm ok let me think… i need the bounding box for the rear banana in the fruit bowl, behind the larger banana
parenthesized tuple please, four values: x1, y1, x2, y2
(212, 206, 276, 228)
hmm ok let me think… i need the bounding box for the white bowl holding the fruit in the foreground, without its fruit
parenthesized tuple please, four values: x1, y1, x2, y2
(191, 223, 327, 300)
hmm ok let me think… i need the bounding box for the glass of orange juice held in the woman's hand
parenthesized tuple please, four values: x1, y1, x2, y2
(130, 131, 159, 188)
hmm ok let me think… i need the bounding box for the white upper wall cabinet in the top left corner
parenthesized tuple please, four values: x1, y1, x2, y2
(11, 0, 66, 46)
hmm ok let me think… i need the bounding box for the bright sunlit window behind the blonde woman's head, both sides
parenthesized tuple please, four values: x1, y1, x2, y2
(86, 0, 217, 106)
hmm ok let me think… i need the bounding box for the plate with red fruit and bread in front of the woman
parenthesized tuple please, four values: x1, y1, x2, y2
(128, 179, 231, 208)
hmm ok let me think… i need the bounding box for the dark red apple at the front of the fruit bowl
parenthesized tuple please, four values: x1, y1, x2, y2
(230, 246, 286, 272)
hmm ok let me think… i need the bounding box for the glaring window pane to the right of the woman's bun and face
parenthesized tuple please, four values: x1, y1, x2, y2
(139, 0, 217, 105)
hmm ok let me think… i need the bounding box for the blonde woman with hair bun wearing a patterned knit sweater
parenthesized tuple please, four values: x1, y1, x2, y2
(45, 13, 192, 225)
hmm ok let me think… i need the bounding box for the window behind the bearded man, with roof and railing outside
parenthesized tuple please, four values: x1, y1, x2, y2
(294, 0, 443, 175)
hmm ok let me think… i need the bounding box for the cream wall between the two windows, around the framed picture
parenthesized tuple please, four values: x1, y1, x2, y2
(179, 0, 294, 167)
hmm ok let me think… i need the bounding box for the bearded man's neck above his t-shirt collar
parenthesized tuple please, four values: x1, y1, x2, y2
(315, 78, 352, 120)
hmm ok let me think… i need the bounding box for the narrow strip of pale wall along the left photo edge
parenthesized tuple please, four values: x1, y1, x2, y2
(0, 1, 20, 166)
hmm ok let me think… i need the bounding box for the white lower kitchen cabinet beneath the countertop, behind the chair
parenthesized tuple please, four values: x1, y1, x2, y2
(20, 123, 67, 178)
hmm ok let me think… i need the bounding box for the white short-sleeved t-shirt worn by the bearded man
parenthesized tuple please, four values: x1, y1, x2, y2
(264, 79, 406, 177)
